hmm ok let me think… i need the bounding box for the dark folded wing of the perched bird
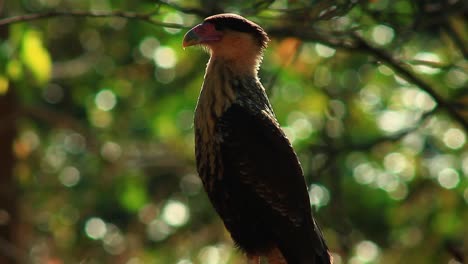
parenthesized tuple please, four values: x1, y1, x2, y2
(217, 104, 328, 263)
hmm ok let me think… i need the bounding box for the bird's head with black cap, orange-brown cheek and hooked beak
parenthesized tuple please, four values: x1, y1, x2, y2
(183, 14, 269, 72)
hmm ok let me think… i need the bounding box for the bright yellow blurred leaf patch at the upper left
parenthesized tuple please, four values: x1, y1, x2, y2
(21, 30, 52, 84)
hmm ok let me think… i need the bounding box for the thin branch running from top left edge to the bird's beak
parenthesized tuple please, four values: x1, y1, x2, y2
(0, 10, 187, 28)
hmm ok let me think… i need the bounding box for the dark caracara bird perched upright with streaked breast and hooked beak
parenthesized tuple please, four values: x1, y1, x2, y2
(182, 13, 332, 264)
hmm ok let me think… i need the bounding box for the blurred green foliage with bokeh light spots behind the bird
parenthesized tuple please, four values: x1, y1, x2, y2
(0, 0, 468, 264)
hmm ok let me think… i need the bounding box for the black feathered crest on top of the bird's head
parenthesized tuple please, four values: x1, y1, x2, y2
(205, 14, 270, 49)
